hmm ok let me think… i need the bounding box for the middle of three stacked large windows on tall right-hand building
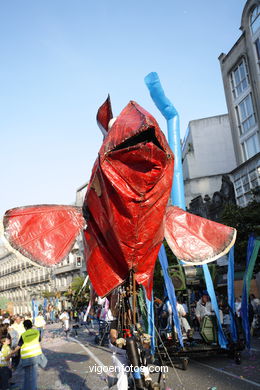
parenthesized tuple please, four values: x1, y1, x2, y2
(237, 95, 255, 134)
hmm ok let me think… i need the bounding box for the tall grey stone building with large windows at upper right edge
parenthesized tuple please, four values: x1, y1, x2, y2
(219, 0, 260, 206)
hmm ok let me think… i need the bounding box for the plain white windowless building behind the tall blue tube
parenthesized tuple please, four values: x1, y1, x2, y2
(182, 114, 236, 208)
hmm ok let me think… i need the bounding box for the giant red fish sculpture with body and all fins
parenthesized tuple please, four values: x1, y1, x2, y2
(0, 98, 236, 296)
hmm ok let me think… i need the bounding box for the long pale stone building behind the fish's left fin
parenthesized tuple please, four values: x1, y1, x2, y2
(0, 239, 85, 314)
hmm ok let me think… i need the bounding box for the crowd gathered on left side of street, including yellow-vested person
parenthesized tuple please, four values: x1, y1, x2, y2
(0, 309, 85, 390)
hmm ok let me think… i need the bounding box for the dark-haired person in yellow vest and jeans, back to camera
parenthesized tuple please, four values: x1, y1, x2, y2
(7, 320, 47, 390)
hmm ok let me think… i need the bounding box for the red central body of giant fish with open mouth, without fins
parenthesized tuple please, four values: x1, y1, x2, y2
(83, 101, 174, 296)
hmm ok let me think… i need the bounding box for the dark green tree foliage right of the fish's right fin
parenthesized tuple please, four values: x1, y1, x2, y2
(219, 201, 260, 272)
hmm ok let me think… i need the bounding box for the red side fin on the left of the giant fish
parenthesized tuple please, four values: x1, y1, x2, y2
(4, 205, 85, 266)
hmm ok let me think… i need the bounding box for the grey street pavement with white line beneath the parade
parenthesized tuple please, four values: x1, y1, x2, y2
(11, 323, 260, 390)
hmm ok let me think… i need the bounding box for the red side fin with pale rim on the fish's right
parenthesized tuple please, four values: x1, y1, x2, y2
(165, 206, 236, 265)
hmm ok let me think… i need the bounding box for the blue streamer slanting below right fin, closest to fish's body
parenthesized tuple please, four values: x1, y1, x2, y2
(159, 245, 183, 347)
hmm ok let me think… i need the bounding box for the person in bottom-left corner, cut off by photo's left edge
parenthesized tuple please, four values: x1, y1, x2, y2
(0, 337, 12, 390)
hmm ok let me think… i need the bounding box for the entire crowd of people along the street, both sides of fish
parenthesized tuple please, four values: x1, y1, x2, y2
(0, 291, 260, 390)
